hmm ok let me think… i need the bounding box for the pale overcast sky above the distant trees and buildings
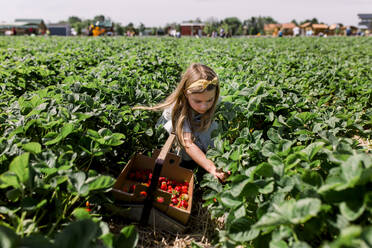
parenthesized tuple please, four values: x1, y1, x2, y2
(0, 0, 372, 26)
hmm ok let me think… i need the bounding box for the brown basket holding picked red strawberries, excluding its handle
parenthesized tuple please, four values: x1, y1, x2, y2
(112, 136, 194, 230)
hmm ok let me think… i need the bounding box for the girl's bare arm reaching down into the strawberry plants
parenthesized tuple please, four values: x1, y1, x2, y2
(183, 132, 228, 182)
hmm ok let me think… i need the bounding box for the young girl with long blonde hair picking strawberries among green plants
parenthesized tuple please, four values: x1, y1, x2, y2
(133, 63, 228, 182)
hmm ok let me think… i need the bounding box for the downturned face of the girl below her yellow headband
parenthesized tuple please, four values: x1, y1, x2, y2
(186, 89, 216, 114)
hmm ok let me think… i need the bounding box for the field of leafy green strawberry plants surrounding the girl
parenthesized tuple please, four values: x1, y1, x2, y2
(0, 37, 372, 248)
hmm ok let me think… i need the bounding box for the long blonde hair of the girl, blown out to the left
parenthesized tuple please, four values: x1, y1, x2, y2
(133, 63, 220, 147)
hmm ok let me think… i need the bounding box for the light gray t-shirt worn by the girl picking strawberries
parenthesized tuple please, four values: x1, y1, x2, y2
(156, 105, 218, 161)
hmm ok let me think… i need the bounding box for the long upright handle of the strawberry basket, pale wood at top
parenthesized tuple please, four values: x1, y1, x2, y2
(140, 133, 176, 226)
